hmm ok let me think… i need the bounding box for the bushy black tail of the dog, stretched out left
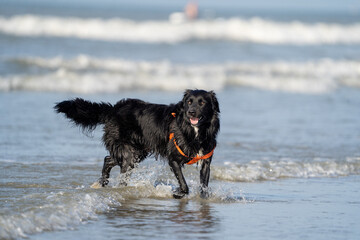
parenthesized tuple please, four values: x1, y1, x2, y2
(54, 98, 114, 131)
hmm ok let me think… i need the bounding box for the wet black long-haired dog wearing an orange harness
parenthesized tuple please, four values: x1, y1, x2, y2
(55, 90, 220, 198)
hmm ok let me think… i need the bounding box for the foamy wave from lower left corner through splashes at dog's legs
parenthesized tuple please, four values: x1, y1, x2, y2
(0, 162, 245, 239)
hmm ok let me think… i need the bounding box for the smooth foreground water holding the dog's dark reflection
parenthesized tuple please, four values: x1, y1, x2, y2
(27, 174, 359, 239)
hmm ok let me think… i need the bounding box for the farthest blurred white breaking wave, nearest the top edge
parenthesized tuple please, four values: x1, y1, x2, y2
(0, 15, 360, 45)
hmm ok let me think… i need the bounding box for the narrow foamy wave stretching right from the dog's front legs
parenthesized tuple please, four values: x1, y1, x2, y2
(211, 158, 360, 182)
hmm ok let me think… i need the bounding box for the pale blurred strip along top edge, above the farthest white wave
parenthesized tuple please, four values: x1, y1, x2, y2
(0, 0, 360, 16)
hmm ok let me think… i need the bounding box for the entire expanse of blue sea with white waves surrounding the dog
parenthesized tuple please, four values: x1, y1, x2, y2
(0, 0, 360, 239)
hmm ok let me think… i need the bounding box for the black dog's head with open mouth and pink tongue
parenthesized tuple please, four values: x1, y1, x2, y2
(182, 90, 220, 127)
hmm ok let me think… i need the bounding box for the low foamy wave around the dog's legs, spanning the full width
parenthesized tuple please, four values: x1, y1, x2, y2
(0, 157, 360, 239)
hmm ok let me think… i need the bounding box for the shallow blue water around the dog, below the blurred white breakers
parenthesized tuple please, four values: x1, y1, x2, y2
(0, 89, 360, 239)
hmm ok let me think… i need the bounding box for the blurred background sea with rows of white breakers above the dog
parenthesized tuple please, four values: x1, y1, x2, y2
(0, 0, 360, 93)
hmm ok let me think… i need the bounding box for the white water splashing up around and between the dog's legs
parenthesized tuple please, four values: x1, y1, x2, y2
(109, 162, 247, 203)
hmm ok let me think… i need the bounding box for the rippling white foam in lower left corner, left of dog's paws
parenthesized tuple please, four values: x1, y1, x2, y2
(0, 192, 121, 239)
